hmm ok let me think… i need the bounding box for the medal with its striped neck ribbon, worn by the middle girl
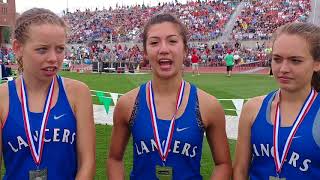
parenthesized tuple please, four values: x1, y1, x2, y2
(148, 80, 185, 179)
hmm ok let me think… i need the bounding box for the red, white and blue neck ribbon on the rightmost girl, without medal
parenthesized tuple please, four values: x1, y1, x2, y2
(273, 89, 318, 174)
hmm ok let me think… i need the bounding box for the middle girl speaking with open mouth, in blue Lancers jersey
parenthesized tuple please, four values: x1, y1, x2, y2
(107, 14, 231, 180)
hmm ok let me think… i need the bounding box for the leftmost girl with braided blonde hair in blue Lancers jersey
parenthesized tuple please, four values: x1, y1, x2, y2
(0, 8, 95, 180)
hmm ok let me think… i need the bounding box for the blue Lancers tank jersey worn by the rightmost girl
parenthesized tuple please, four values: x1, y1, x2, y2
(249, 92, 320, 180)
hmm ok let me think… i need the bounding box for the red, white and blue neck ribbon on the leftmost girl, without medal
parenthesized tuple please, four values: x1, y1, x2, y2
(21, 76, 55, 166)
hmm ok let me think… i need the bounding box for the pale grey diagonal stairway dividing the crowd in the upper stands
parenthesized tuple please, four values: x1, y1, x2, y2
(217, 2, 247, 43)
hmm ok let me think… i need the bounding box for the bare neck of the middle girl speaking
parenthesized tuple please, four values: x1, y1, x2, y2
(152, 76, 183, 95)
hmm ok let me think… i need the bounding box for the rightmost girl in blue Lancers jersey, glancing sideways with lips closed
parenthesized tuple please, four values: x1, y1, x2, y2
(234, 23, 320, 180)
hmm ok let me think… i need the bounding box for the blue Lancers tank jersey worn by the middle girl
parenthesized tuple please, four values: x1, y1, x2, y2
(130, 84, 204, 180)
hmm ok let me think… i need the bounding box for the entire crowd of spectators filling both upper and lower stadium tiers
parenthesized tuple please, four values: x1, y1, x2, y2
(35, 0, 311, 71)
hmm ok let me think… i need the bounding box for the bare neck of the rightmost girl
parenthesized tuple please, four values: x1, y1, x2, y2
(281, 87, 311, 103)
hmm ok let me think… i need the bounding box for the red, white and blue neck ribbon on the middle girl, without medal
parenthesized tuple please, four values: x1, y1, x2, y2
(148, 80, 185, 162)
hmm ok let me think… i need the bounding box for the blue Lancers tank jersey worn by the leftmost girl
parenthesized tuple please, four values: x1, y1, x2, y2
(2, 76, 77, 180)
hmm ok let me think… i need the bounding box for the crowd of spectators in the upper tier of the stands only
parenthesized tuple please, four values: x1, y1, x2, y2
(64, 0, 311, 43)
